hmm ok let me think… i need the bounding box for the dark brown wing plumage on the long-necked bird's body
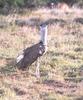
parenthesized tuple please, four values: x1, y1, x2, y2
(17, 42, 45, 70)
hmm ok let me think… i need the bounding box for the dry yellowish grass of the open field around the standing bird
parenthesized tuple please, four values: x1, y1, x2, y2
(0, 9, 83, 100)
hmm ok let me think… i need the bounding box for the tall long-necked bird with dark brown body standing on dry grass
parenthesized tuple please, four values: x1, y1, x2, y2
(16, 23, 48, 78)
